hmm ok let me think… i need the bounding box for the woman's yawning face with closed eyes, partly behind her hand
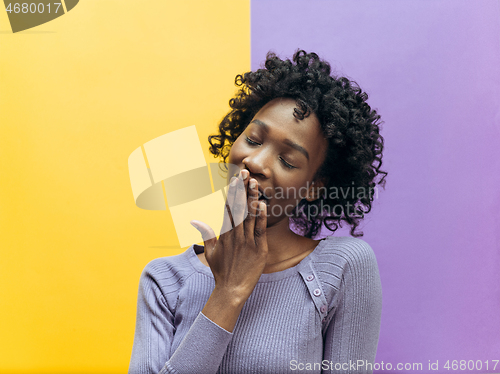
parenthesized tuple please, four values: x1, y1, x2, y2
(228, 98, 328, 226)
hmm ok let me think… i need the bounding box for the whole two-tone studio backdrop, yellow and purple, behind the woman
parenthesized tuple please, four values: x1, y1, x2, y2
(0, 0, 500, 373)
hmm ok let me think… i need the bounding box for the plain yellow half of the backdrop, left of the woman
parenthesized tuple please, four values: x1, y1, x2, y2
(0, 0, 250, 373)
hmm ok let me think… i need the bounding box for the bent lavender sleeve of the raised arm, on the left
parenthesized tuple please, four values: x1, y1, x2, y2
(129, 261, 233, 374)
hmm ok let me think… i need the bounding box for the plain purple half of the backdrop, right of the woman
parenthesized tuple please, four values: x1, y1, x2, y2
(251, 0, 500, 373)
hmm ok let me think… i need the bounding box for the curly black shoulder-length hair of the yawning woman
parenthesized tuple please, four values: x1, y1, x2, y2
(208, 50, 387, 238)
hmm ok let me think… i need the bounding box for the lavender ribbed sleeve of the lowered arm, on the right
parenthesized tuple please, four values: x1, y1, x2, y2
(322, 240, 382, 373)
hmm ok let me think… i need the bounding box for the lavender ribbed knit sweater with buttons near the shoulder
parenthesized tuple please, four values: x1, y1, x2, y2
(129, 236, 382, 374)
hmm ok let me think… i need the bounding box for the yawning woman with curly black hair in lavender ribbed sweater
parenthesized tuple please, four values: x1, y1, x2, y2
(129, 50, 387, 374)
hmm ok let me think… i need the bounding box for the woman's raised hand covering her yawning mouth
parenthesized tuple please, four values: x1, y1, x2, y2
(191, 170, 267, 331)
